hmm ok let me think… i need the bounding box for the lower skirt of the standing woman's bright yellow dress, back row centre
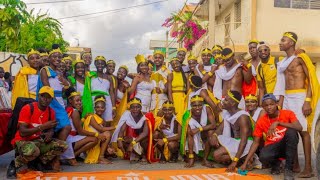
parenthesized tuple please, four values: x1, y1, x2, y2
(172, 92, 186, 124)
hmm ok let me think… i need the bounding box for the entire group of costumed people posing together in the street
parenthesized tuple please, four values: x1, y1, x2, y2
(6, 32, 318, 177)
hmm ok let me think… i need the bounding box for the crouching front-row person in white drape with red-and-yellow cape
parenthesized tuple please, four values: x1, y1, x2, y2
(111, 98, 155, 164)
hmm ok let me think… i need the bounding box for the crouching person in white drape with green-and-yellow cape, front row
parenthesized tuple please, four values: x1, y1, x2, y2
(180, 95, 216, 168)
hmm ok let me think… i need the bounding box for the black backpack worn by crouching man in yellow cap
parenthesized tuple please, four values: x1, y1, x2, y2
(6, 97, 51, 142)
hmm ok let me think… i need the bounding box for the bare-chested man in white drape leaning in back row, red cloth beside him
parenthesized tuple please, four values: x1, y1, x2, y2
(213, 48, 252, 109)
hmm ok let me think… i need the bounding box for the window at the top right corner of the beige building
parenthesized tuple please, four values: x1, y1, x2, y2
(274, 0, 320, 9)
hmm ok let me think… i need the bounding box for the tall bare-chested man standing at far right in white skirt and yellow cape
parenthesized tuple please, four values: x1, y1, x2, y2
(274, 32, 318, 178)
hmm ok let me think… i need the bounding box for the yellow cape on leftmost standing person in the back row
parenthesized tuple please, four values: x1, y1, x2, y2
(11, 66, 37, 108)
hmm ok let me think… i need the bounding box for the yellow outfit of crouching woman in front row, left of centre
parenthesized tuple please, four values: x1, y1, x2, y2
(82, 114, 103, 164)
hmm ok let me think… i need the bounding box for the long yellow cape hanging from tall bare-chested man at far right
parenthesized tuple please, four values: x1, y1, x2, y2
(298, 53, 319, 132)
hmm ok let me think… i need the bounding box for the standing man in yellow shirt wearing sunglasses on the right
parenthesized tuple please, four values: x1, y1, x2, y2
(257, 42, 279, 105)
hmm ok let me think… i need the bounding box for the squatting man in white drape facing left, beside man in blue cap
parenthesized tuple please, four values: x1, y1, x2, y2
(212, 91, 253, 171)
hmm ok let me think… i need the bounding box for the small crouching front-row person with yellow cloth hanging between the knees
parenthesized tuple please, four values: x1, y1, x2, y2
(153, 101, 181, 163)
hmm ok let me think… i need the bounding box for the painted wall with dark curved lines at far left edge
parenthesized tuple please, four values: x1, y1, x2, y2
(0, 52, 28, 76)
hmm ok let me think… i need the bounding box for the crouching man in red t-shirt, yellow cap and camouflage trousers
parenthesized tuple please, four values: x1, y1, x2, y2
(11, 86, 68, 171)
